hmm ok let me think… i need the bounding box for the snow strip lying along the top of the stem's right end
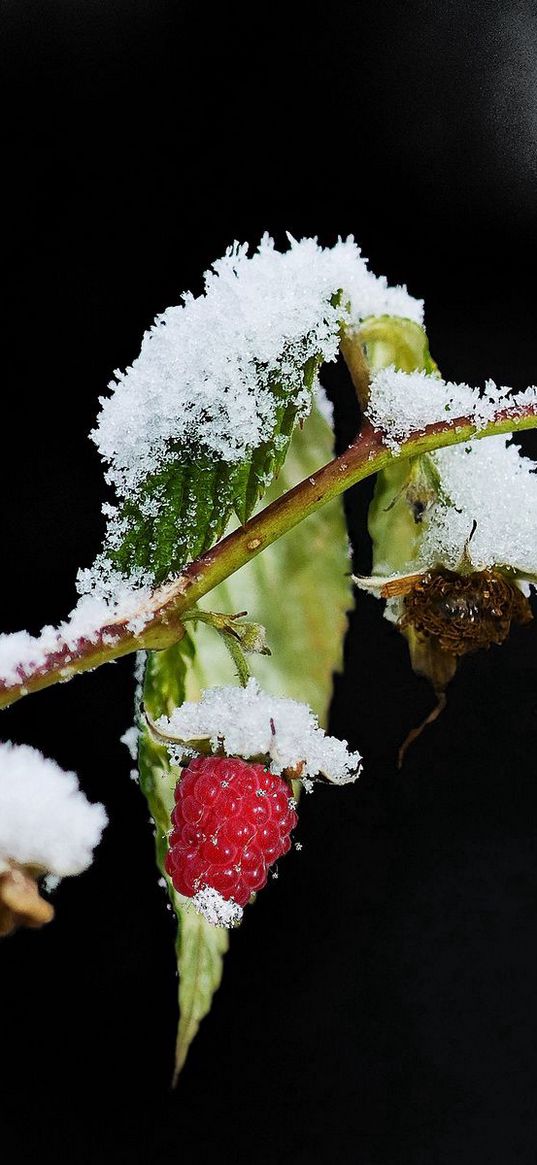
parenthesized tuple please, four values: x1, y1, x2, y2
(367, 367, 537, 452)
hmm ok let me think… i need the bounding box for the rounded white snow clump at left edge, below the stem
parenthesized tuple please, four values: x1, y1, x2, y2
(0, 743, 107, 877)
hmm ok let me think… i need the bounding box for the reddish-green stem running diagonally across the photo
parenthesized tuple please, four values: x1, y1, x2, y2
(0, 404, 537, 708)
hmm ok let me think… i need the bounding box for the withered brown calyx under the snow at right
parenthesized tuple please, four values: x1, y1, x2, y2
(400, 570, 532, 656)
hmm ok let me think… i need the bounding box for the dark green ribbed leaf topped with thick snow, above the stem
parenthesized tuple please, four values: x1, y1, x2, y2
(86, 236, 422, 591)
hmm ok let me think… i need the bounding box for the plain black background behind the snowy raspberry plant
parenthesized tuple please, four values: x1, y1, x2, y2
(0, 0, 537, 1165)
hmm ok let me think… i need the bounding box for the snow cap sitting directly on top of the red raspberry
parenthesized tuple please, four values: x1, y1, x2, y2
(156, 679, 361, 784)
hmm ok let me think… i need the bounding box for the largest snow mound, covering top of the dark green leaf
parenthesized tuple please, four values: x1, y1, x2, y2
(92, 235, 422, 505)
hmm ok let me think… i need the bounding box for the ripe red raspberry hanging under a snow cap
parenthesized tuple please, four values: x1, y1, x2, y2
(165, 756, 297, 906)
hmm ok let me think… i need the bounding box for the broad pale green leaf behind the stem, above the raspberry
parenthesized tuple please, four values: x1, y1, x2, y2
(181, 407, 353, 725)
